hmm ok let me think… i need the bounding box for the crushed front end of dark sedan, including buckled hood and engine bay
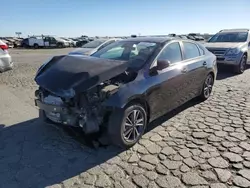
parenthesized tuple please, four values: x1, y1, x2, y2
(35, 55, 134, 133)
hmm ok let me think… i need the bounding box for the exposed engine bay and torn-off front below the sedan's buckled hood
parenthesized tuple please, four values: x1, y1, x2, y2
(35, 71, 137, 134)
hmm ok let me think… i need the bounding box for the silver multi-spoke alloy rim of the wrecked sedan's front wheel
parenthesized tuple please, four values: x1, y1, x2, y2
(123, 109, 146, 142)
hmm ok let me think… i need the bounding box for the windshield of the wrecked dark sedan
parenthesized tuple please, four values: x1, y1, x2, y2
(92, 41, 158, 68)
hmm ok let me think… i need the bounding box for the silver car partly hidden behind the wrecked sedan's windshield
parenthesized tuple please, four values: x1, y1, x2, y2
(69, 38, 119, 55)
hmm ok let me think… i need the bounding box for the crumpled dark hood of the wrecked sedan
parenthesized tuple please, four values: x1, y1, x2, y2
(35, 55, 128, 98)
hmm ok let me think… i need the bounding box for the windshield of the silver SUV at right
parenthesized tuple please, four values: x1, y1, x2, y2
(208, 32, 248, 42)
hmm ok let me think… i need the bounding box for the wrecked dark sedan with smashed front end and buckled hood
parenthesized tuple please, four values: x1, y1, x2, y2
(35, 37, 217, 147)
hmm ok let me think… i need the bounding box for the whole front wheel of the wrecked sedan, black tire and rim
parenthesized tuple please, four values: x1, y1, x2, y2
(108, 103, 147, 148)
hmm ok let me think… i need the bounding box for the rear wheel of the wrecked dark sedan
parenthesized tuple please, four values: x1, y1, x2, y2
(200, 74, 214, 100)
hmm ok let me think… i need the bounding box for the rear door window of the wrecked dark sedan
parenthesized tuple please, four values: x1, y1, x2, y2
(183, 42, 200, 59)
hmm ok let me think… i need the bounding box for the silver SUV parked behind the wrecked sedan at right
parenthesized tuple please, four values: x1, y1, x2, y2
(205, 29, 250, 74)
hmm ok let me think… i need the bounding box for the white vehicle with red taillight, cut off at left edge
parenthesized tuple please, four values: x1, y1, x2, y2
(0, 40, 13, 72)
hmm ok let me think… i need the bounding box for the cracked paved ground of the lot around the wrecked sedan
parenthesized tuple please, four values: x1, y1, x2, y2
(0, 49, 250, 188)
